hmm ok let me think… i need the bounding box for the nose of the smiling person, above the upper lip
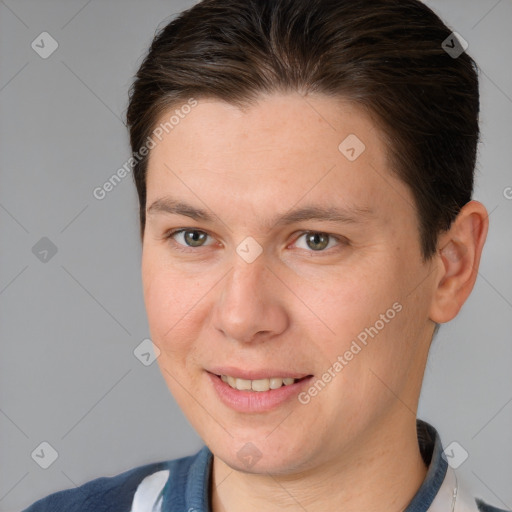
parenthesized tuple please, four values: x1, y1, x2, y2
(213, 254, 289, 343)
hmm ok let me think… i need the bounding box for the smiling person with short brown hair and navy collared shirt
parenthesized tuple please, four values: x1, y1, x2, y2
(21, 0, 508, 512)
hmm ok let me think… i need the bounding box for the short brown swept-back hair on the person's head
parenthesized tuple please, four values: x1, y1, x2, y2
(127, 0, 479, 260)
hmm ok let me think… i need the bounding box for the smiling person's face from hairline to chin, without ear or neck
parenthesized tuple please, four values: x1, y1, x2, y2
(142, 95, 434, 474)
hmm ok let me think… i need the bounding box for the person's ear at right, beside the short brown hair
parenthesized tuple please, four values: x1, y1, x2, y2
(430, 201, 489, 323)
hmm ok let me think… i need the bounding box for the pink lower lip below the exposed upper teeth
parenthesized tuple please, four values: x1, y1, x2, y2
(207, 372, 313, 413)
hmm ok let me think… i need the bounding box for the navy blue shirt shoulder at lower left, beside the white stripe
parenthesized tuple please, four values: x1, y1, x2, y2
(23, 454, 206, 512)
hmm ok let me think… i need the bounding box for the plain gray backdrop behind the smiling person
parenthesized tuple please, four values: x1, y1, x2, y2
(0, 0, 512, 512)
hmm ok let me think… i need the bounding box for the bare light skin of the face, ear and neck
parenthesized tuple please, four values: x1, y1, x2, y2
(142, 94, 488, 512)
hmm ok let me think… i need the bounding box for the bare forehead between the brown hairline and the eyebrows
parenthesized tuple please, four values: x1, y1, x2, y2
(143, 94, 412, 228)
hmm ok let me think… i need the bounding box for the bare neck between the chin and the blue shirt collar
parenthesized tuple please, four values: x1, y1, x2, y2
(211, 415, 427, 512)
